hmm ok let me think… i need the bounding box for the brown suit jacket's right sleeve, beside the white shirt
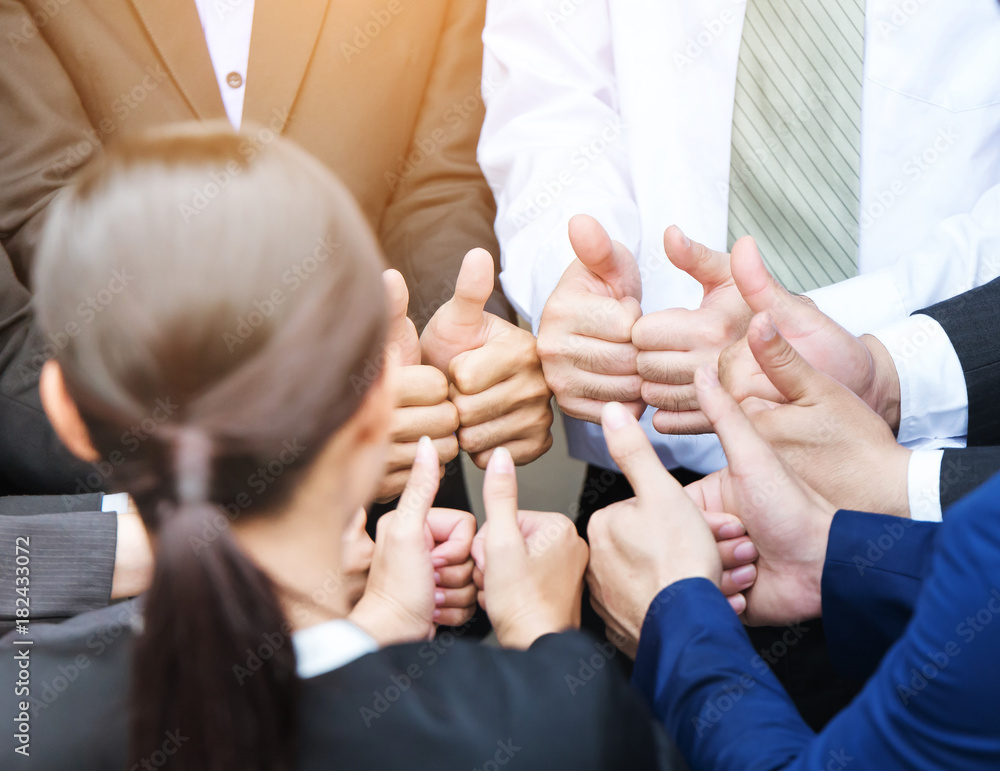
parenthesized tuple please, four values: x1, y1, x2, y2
(379, 0, 513, 331)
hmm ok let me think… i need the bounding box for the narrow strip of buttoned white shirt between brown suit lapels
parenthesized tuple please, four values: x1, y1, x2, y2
(195, 0, 254, 131)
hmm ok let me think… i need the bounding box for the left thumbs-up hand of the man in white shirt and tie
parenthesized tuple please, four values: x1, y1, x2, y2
(538, 215, 646, 423)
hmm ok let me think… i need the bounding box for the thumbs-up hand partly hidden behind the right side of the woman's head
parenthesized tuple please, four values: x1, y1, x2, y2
(375, 270, 458, 503)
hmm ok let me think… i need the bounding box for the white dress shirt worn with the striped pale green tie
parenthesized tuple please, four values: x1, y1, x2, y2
(479, 0, 1000, 520)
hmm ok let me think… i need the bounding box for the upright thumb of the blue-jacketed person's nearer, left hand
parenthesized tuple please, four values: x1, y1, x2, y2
(601, 402, 682, 506)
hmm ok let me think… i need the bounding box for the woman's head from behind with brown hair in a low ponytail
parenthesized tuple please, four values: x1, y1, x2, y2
(35, 125, 389, 768)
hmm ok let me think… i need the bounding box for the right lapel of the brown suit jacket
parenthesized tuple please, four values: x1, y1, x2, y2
(243, 0, 329, 126)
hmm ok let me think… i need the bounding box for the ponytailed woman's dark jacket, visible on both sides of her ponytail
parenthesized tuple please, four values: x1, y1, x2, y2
(0, 602, 657, 771)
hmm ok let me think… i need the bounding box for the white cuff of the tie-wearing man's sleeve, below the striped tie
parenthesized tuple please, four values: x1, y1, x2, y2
(806, 273, 908, 335)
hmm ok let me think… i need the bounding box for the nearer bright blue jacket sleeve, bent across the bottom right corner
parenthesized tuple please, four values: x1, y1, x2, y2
(633, 480, 1000, 771)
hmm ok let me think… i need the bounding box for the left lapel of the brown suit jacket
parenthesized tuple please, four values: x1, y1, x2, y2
(132, 0, 226, 120)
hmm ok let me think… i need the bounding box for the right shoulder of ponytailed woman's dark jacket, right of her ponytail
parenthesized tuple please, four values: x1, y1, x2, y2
(302, 633, 656, 771)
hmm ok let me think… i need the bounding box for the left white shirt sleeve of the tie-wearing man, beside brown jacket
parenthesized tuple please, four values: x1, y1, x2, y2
(479, 0, 640, 333)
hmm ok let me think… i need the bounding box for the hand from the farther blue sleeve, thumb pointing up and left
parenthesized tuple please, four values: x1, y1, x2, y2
(685, 366, 835, 626)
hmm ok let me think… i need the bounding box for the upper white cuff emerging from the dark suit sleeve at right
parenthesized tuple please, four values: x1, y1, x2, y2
(873, 313, 969, 444)
